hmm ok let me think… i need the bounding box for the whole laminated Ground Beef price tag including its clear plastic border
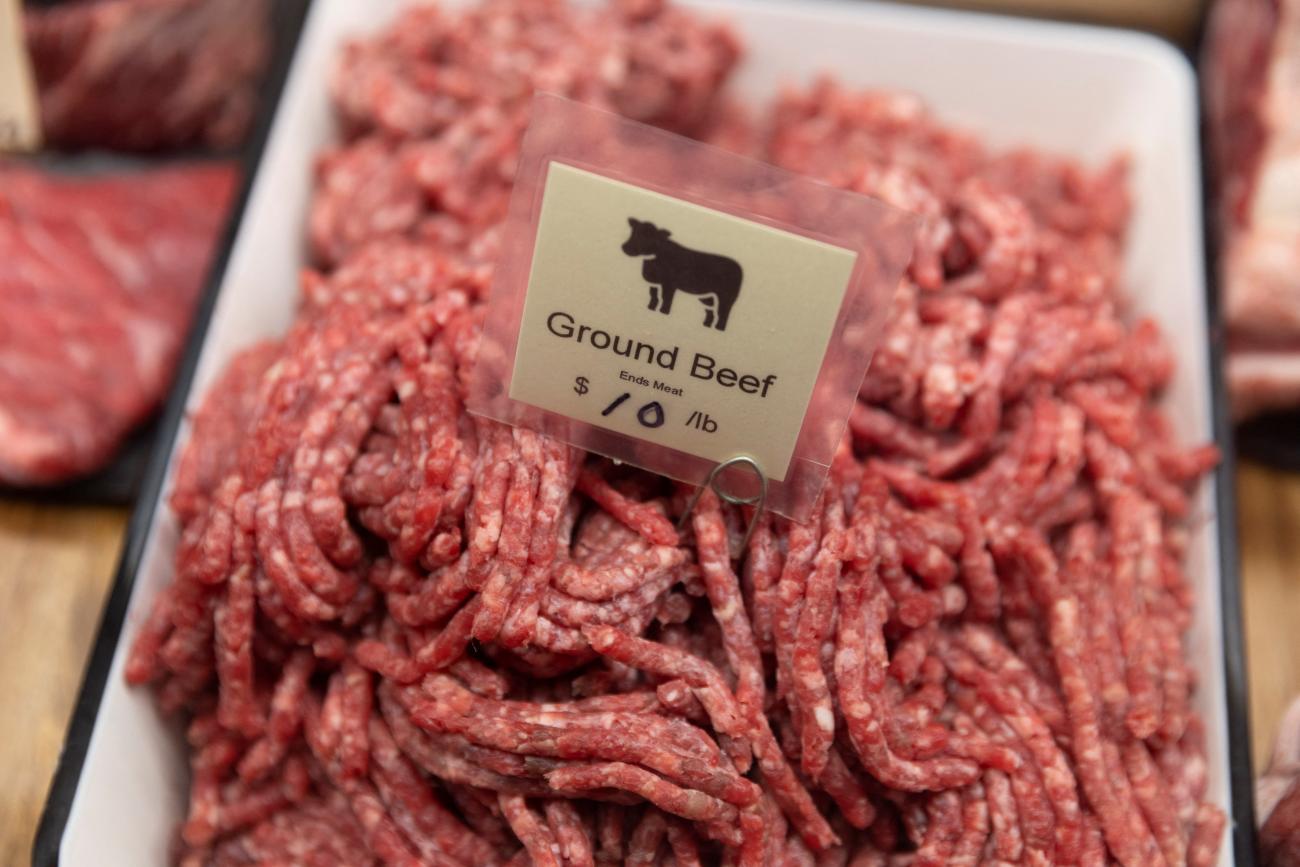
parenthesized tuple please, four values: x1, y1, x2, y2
(469, 95, 914, 519)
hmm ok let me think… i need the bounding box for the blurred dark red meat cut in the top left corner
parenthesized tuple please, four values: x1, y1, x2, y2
(23, 0, 270, 151)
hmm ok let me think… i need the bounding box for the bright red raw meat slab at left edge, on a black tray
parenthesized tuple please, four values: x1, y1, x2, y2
(0, 164, 237, 485)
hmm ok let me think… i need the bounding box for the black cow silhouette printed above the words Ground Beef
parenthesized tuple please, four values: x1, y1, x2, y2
(623, 217, 745, 331)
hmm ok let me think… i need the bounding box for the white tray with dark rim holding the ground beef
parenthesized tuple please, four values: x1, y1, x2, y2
(48, 0, 1234, 867)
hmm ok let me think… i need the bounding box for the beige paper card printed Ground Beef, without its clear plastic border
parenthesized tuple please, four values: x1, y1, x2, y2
(510, 162, 857, 481)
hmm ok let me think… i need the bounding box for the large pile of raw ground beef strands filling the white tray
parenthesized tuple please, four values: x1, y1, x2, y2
(127, 0, 1225, 867)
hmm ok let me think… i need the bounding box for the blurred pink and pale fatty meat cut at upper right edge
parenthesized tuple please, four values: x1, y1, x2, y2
(1204, 0, 1300, 417)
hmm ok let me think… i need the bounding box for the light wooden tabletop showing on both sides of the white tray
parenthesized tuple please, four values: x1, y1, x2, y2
(0, 464, 1300, 864)
